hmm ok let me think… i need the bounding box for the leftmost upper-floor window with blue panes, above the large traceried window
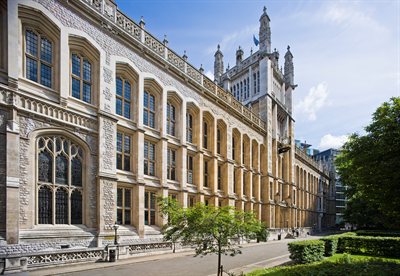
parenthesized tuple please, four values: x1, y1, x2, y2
(25, 29, 53, 88)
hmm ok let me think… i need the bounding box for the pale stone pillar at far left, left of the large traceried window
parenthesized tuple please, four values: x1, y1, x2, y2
(5, 109, 20, 244)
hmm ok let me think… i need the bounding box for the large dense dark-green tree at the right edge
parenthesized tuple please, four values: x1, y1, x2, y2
(336, 97, 400, 229)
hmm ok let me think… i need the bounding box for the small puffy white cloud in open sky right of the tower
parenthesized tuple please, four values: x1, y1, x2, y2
(295, 82, 329, 121)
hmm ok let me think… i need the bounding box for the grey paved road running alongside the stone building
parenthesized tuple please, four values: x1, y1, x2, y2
(59, 237, 318, 276)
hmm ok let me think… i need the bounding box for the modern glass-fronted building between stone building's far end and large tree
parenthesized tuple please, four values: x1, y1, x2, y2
(314, 149, 347, 225)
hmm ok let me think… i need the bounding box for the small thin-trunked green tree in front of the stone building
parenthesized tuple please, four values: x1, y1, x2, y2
(158, 198, 265, 275)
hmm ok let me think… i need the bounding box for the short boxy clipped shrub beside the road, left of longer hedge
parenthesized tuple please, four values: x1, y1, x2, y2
(288, 240, 325, 264)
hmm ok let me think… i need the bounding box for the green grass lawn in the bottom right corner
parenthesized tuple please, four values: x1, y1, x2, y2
(246, 254, 400, 276)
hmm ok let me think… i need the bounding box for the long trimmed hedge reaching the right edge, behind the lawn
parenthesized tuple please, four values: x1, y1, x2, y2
(337, 236, 400, 258)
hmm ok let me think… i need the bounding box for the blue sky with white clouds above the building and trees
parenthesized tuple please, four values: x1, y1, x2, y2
(117, 0, 400, 149)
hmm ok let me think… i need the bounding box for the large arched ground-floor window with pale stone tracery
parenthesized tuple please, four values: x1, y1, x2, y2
(37, 136, 83, 224)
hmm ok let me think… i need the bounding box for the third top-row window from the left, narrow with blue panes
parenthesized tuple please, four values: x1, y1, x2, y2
(115, 77, 132, 119)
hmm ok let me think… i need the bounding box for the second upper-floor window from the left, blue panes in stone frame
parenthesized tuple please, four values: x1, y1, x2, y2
(71, 53, 92, 103)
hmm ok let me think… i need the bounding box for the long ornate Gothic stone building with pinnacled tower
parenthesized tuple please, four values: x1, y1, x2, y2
(0, 0, 328, 263)
